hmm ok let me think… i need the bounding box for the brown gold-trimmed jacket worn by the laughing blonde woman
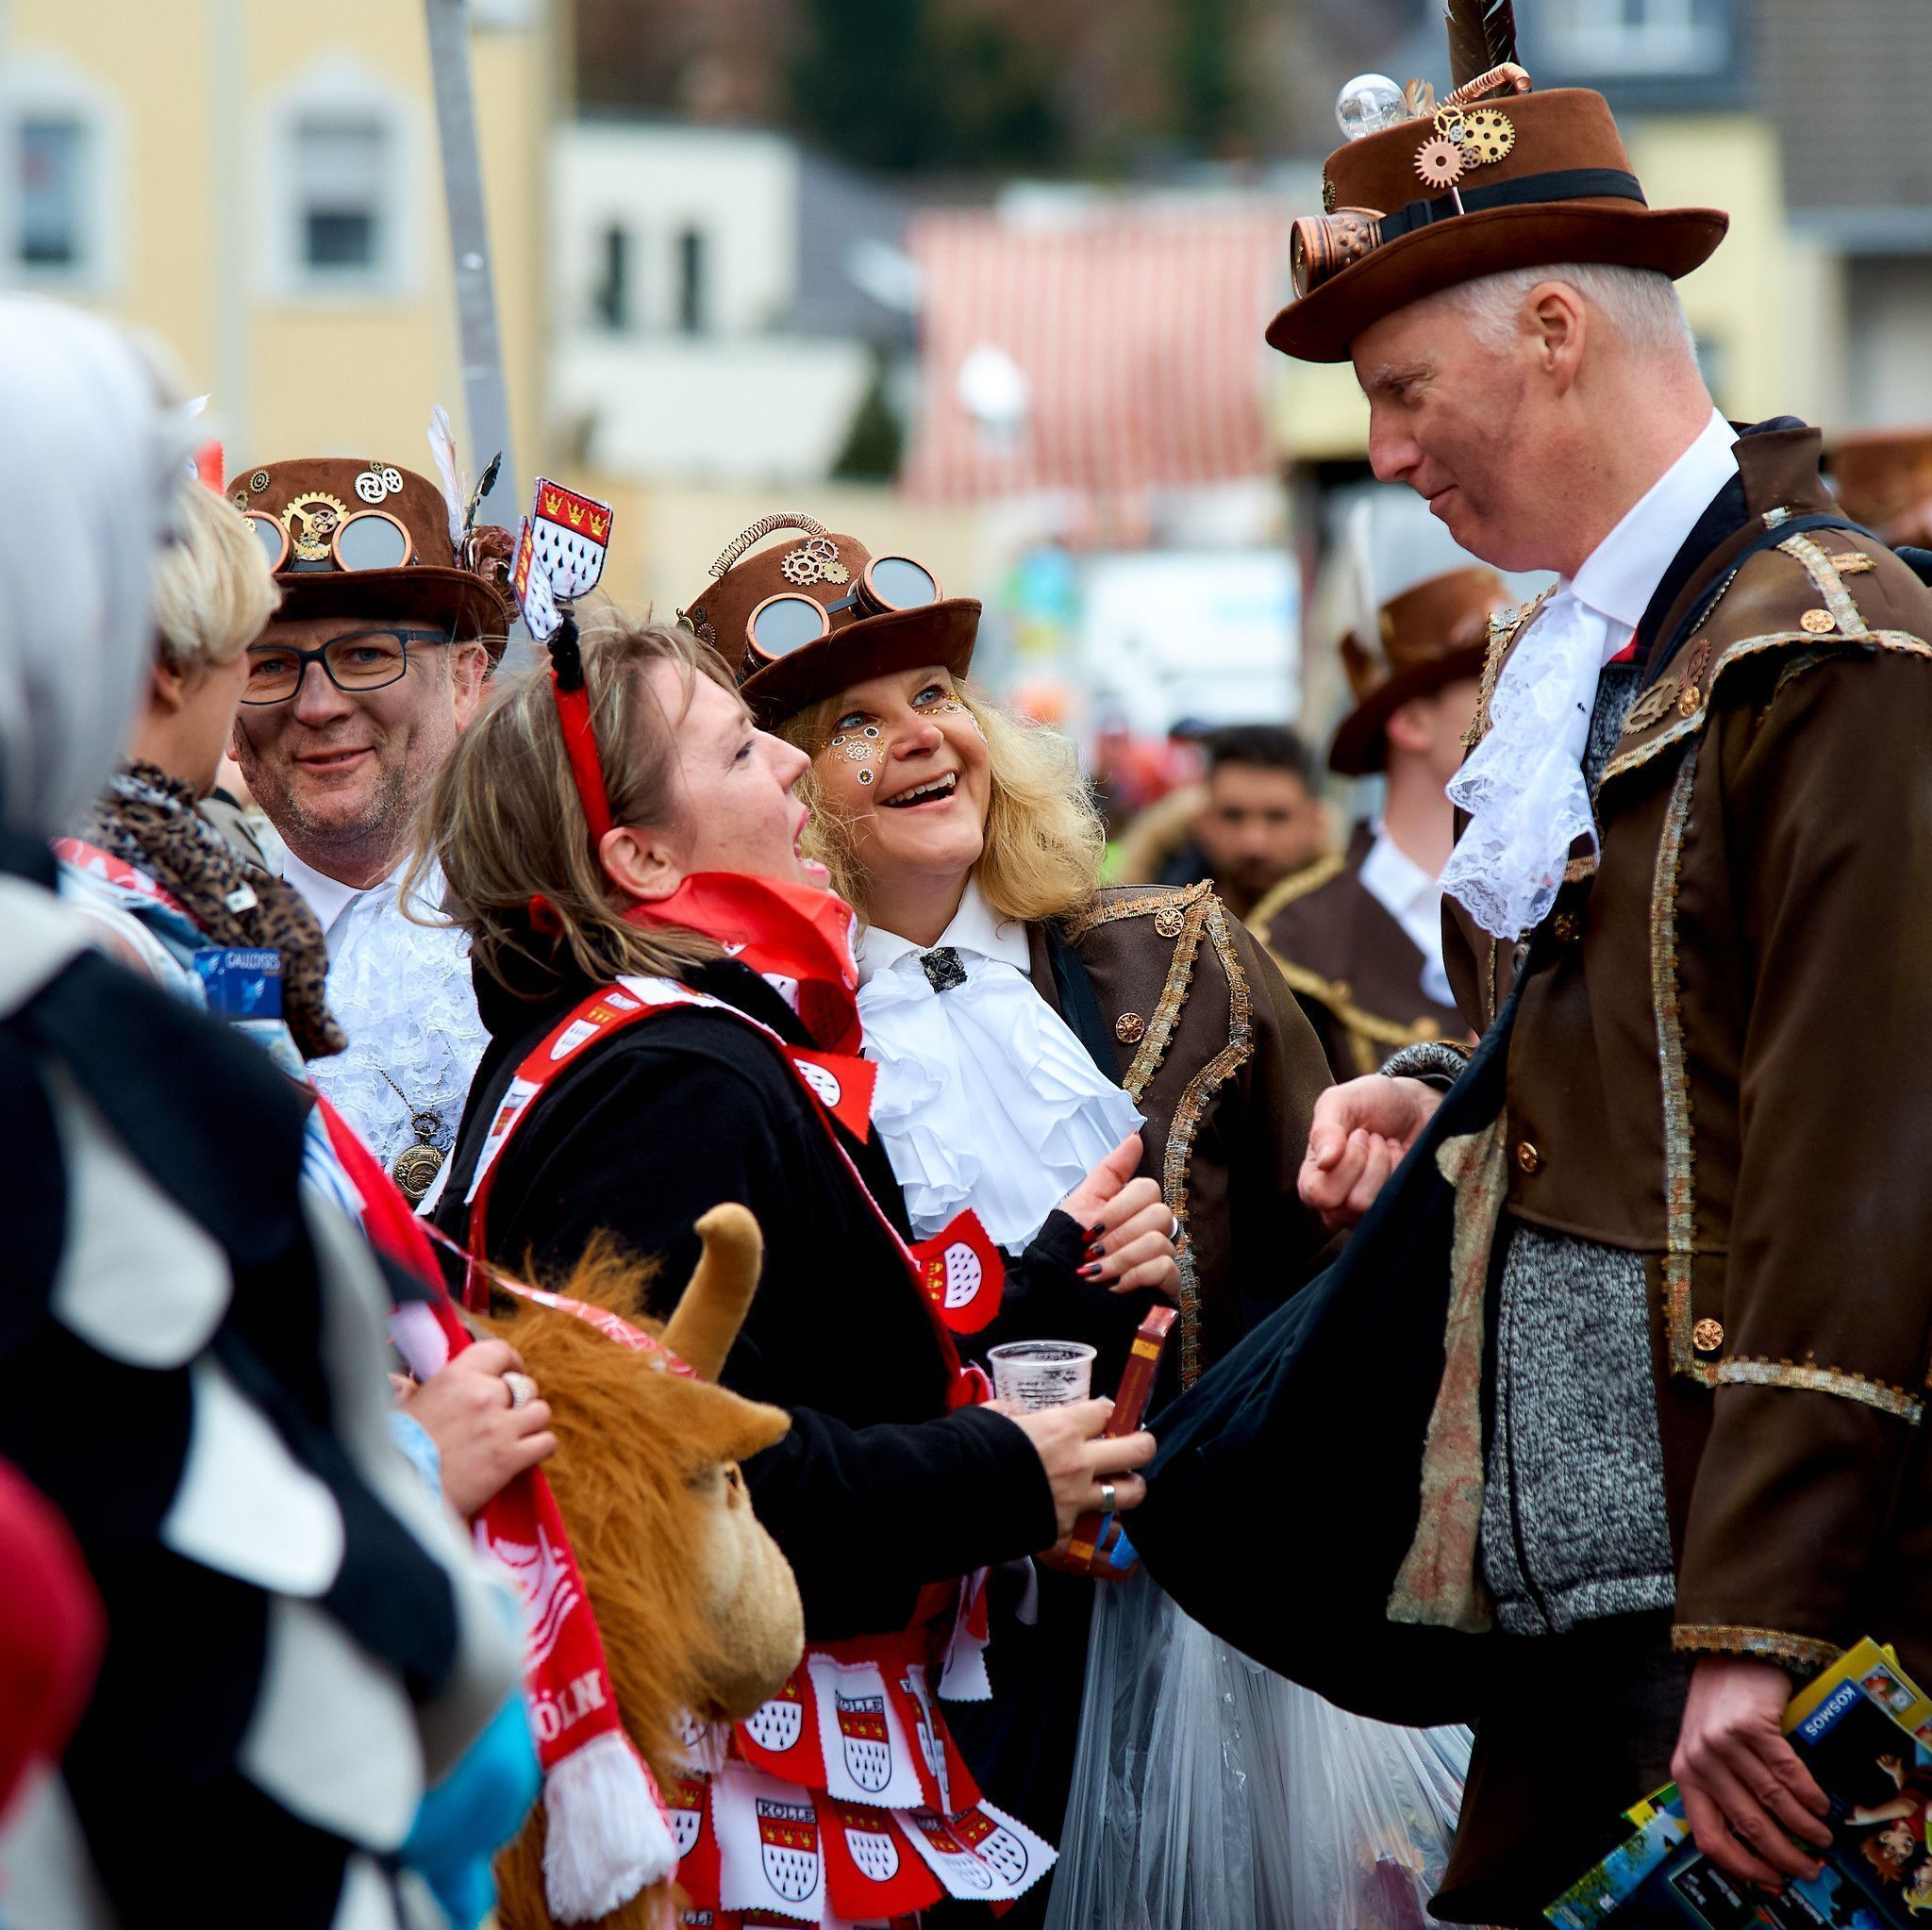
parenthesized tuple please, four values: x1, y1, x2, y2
(1028, 883, 1329, 1383)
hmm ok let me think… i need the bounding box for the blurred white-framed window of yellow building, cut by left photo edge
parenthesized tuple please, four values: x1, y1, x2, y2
(0, 54, 120, 291)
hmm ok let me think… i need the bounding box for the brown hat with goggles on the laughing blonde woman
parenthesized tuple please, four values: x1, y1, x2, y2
(678, 512, 979, 726)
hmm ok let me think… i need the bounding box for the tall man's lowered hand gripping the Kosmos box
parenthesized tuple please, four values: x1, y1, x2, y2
(1672, 1655, 1832, 1889)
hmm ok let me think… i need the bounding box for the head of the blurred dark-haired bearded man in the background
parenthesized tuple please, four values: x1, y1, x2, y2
(1154, 724, 1329, 920)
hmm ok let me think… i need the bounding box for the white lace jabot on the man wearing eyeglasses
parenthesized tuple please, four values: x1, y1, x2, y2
(284, 852, 485, 1167)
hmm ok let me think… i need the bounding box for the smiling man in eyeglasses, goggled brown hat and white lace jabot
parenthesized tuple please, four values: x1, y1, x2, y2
(228, 458, 508, 1200)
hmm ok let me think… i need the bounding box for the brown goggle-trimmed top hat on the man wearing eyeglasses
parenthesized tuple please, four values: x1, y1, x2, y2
(228, 456, 514, 660)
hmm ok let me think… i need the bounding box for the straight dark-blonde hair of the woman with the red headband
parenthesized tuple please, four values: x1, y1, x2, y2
(402, 610, 732, 997)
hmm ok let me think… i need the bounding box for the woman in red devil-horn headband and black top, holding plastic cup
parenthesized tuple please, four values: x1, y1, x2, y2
(415, 620, 1152, 1921)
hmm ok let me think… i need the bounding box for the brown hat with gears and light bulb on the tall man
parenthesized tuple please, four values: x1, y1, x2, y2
(1267, 23, 1729, 361)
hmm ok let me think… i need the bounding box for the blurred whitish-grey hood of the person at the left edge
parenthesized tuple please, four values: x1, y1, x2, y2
(0, 295, 184, 837)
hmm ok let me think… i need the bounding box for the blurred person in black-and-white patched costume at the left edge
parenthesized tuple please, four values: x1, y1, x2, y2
(0, 299, 518, 1924)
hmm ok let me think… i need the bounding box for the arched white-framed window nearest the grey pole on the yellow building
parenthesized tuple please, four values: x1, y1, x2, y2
(260, 56, 427, 301)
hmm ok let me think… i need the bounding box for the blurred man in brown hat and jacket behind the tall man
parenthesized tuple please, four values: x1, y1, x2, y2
(1248, 570, 1507, 1080)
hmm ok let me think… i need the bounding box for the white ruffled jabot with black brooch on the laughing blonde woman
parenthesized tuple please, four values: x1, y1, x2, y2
(858, 883, 1141, 1250)
